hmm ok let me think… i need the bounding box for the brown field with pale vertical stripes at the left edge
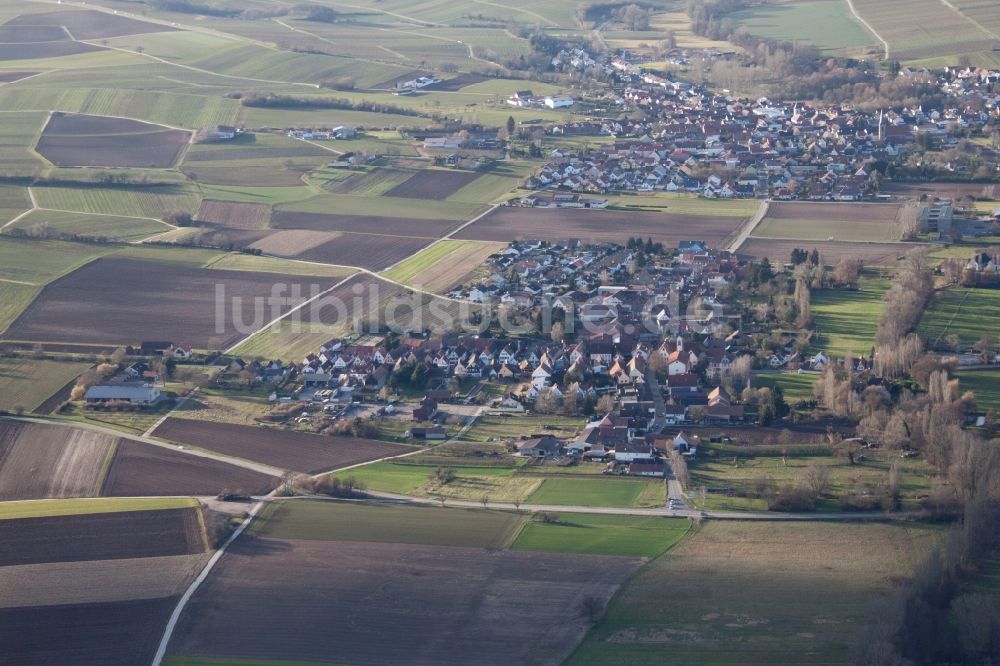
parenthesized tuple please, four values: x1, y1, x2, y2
(0, 421, 116, 500)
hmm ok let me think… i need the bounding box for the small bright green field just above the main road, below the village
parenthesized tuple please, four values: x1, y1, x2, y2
(525, 478, 667, 507)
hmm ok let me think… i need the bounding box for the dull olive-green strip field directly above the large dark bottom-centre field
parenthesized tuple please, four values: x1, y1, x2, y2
(252, 500, 525, 548)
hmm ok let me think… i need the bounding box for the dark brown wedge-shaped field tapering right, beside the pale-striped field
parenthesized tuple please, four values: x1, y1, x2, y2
(101, 439, 278, 497)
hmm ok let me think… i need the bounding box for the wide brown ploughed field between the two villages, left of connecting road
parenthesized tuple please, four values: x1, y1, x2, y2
(455, 207, 746, 247)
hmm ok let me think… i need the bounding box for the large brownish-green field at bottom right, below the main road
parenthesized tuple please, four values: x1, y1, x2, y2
(567, 521, 942, 666)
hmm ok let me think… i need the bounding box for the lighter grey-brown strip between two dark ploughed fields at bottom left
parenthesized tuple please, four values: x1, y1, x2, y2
(0, 553, 211, 608)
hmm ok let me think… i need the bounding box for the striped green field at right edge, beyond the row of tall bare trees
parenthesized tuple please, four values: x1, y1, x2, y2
(917, 287, 1000, 347)
